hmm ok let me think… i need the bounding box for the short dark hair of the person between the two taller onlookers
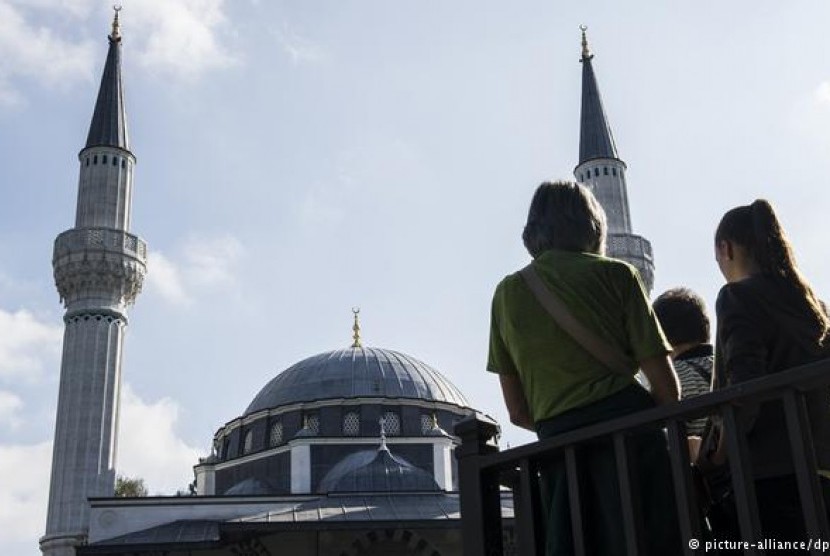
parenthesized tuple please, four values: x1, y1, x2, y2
(653, 288, 709, 346)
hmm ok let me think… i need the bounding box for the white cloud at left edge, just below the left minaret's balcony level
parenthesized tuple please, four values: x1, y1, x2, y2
(0, 309, 63, 380)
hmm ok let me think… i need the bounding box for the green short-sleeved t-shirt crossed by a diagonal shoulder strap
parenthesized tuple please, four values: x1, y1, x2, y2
(487, 249, 671, 422)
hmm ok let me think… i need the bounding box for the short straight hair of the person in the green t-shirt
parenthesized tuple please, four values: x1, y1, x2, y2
(522, 181, 606, 258)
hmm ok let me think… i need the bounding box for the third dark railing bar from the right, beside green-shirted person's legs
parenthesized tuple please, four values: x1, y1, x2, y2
(667, 420, 701, 555)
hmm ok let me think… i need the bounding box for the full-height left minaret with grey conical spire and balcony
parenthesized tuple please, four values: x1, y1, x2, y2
(40, 8, 147, 556)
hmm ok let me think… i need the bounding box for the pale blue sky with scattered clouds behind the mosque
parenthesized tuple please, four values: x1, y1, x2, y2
(0, 0, 830, 556)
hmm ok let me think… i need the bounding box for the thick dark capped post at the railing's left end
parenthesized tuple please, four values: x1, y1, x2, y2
(455, 413, 504, 556)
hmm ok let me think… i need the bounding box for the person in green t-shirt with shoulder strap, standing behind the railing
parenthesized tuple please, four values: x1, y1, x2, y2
(487, 182, 681, 556)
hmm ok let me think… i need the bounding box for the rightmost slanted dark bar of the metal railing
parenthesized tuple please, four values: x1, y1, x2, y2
(783, 390, 830, 554)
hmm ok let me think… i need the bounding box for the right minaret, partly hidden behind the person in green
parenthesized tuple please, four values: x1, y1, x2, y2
(574, 25, 654, 293)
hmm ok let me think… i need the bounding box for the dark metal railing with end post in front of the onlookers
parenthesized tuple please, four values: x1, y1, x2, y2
(455, 359, 830, 556)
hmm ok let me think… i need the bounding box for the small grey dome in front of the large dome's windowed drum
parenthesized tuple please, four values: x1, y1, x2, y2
(318, 444, 440, 492)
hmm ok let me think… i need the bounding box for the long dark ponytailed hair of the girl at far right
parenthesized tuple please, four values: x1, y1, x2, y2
(715, 199, 830, 343)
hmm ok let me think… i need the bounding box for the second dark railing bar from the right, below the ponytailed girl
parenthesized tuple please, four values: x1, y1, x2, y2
(723, 405, 761, 554)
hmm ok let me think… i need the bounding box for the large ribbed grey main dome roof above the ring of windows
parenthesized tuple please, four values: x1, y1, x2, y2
(245, 347, 469, 415)
